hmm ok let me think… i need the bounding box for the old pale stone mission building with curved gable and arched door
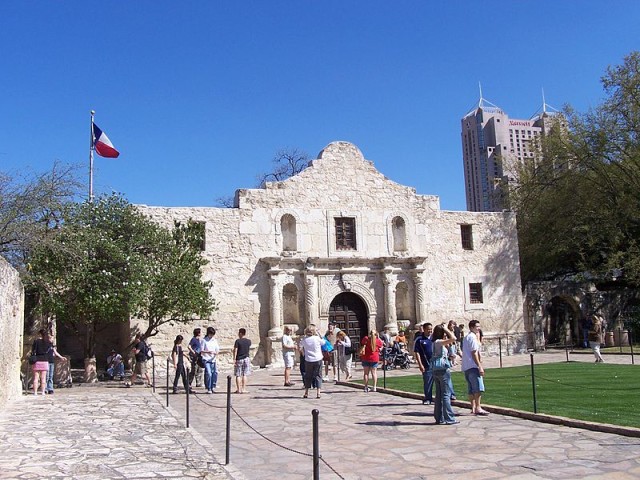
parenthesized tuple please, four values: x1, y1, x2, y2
(134, 142, 532, 366)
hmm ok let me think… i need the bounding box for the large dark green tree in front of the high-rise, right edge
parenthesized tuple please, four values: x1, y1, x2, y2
(511, 52, 640, 286)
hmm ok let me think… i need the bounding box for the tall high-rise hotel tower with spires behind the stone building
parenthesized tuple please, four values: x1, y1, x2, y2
(461, 96, 555, 212)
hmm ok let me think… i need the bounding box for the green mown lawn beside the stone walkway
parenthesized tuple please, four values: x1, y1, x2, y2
(378, 362, 640, 427)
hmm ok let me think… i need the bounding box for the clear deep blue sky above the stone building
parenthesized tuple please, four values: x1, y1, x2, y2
(0, 0, 640, 210)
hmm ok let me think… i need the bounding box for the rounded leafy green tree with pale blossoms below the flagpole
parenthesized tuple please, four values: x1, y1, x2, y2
(29, 194, 215, 358)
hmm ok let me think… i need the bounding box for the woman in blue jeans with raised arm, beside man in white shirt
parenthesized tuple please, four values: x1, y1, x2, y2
(431, 323, 460, 425)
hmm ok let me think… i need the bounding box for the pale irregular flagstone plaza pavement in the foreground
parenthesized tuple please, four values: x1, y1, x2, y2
(0, 353, 640, 480)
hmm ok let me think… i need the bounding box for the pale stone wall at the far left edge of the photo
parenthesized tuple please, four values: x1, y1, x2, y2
(0, 256, 24, 407)
